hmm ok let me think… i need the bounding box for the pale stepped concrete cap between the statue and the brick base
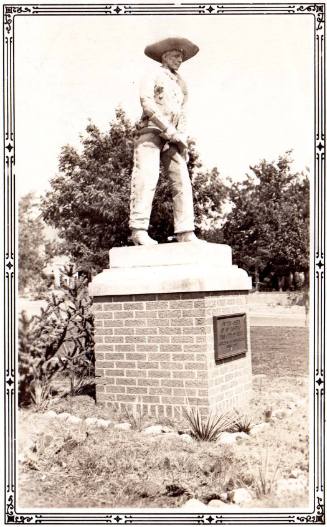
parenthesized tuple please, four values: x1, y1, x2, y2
(89, 242, 252, 297)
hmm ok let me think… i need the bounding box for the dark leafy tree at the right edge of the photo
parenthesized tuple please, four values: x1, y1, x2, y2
(223, 152, 309, 290)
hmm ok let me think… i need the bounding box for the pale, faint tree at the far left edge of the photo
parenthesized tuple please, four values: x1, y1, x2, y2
(18, 193, 55, 293)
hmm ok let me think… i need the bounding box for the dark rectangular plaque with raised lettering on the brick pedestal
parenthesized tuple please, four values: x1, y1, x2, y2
(213, 313, 247, 361)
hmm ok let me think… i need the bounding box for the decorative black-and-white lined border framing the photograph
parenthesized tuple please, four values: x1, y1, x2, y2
(3, 3, 326, 525)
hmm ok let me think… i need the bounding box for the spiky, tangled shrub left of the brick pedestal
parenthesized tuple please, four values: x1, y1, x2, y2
(18, 267, 94, 407)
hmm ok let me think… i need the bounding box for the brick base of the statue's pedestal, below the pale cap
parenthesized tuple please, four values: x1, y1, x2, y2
(93, 292, 251, 416)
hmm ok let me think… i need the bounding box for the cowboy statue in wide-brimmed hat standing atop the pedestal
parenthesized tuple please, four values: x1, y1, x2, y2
(129, 38, 199, 245)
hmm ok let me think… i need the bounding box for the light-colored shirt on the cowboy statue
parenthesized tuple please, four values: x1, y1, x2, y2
(138, 66, 187, 134)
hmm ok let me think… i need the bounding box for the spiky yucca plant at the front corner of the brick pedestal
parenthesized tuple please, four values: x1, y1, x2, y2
(183, 406, 233, 441)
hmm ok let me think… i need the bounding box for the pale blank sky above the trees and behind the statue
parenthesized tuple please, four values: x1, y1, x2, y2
(15, 15, 314, 196)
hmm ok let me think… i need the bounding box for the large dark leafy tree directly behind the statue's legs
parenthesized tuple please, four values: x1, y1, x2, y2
(42, 108, 226, 271)
